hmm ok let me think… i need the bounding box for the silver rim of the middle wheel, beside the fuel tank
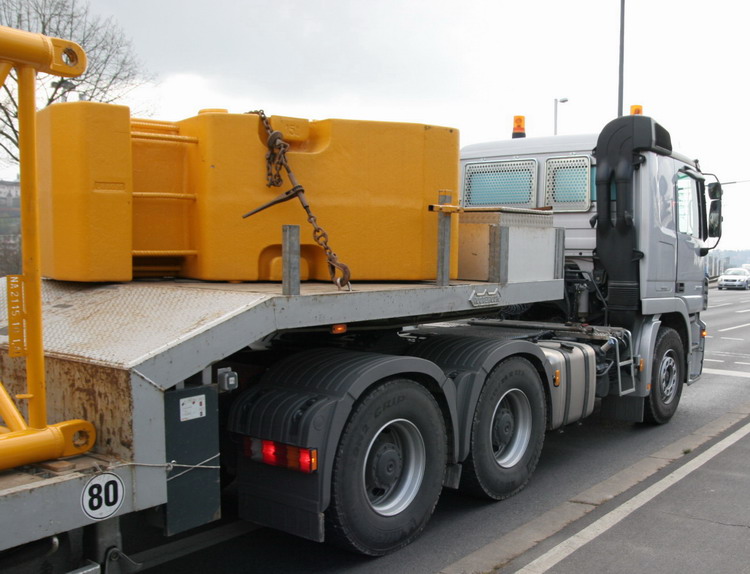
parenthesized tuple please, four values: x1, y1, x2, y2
(490, 389, 532, 468)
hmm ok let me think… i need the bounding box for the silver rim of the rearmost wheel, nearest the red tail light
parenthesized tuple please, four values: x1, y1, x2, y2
(362, 419, 427, 516)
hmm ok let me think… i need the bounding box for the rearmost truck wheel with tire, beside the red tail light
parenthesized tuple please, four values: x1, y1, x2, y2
(326, 379, 447, 556)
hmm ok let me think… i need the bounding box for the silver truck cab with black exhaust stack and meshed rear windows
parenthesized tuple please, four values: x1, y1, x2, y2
(461, 116, 721, 424)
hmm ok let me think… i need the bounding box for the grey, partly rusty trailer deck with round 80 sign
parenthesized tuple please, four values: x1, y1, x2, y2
(0, 279, 563, 550)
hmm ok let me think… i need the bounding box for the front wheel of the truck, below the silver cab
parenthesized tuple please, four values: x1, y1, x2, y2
(644, 327, 685, 425)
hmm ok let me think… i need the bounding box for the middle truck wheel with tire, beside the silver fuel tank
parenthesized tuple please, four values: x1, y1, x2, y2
(461, 357, 546, 500)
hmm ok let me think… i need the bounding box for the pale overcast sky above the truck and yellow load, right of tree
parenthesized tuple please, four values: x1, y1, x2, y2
(85, 0, 750, 249)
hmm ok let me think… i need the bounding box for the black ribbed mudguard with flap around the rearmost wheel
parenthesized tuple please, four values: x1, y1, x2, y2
(228, 349, 457, 541)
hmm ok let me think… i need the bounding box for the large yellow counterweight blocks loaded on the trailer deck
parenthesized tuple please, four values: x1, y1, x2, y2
(38, 102, 459, 281)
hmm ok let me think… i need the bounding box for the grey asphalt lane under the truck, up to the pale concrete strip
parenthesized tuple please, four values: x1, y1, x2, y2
(141, 288, 750, 574)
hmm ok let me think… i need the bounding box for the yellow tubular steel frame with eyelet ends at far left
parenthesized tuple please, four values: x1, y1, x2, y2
(0, 26, 96, 470)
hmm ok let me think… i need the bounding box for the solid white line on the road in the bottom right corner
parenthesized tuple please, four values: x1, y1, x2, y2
(516, 423, 750, 574)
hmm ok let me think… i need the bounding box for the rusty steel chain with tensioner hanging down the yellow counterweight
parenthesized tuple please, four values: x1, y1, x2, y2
(247, 110, 351, 290)
